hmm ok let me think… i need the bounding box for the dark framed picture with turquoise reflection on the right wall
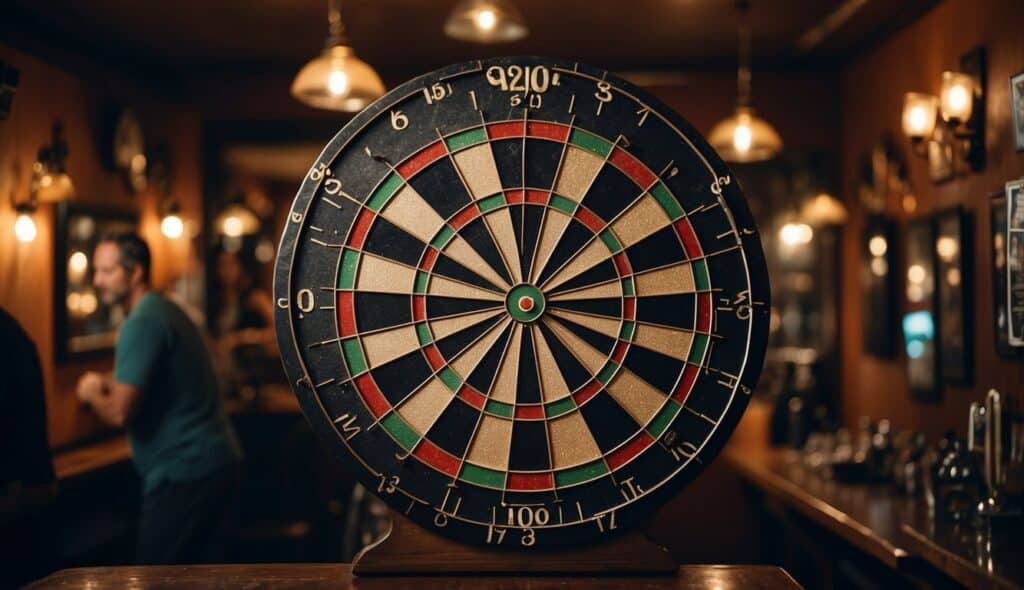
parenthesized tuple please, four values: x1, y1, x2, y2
(901, 217, 941, 401)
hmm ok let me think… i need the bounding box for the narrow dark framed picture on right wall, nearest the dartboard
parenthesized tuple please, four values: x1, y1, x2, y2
(860, 215, 898, 359)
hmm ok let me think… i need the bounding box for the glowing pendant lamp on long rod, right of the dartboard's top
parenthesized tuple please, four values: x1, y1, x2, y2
(708, 0, 782, 162)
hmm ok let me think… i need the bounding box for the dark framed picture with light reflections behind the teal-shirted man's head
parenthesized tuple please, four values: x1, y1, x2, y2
(53, 203, 138, 361)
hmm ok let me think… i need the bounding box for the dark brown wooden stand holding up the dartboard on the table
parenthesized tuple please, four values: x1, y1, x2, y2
(352, 510, 679, 576)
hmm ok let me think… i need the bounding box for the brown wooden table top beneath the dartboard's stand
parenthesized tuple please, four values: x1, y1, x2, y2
(28, 563, 800, 590)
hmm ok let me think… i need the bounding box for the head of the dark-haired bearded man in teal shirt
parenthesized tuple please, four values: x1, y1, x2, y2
(92, 233, 150, 305)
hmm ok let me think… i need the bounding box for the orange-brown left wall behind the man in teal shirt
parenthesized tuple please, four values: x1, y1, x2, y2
(0, 45, 202, 446)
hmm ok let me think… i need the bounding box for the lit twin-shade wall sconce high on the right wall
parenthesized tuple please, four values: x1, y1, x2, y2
(902, 47, 985, 171)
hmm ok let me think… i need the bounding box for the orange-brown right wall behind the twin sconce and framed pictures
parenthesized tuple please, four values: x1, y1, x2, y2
(841, 0, 1024, 437)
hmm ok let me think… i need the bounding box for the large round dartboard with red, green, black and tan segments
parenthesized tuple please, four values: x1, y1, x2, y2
(274, 57, 769, 549)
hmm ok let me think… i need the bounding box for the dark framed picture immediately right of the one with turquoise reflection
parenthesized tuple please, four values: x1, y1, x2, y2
(935, 207, 974, 385)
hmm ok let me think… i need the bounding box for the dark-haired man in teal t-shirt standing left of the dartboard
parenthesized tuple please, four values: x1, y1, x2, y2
(78, 234, 242, 563)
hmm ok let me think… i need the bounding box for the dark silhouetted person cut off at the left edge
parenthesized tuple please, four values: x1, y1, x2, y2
(0, 308, 56, 588)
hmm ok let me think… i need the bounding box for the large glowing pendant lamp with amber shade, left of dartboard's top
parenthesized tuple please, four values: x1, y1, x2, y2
(292, 0, 384, 113)
